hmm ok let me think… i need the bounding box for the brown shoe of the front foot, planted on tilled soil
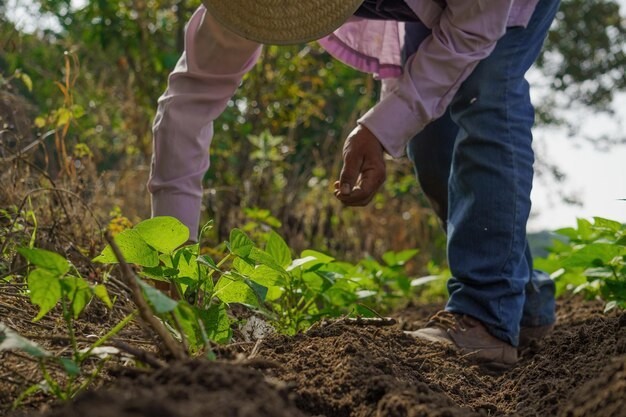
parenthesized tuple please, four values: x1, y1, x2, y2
(406, 311, 517, 370)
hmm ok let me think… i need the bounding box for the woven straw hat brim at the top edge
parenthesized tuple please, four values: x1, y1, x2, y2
(202, 0, 363, 44)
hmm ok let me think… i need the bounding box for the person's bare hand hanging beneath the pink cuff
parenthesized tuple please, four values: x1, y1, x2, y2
(335, 125, 386, 206)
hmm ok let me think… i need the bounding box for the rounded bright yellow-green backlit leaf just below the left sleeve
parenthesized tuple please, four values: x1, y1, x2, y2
(134, 216, 189, 253)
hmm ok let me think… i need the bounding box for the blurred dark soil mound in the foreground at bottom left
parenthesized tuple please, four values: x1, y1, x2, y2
(29, 360, 305, 417)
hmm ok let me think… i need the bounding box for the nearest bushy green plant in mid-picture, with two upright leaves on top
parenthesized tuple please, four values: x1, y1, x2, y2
(225, 229, 369, 334)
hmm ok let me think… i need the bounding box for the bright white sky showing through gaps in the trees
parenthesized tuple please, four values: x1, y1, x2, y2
(7, 0, 626, 231)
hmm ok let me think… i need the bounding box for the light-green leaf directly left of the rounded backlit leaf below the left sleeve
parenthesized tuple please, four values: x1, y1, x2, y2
(94, 229, 159, 267)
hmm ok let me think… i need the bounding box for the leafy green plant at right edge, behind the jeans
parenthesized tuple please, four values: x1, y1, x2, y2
(535, 217, 626, 311)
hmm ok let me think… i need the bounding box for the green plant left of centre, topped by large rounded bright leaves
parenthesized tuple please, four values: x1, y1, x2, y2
(94, 216, 236, 353)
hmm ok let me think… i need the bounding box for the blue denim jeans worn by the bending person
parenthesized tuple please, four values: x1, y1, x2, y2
(406, 0, 559, 346)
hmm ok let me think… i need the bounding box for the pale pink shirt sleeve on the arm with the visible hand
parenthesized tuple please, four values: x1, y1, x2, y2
(358, 0, 513, 157)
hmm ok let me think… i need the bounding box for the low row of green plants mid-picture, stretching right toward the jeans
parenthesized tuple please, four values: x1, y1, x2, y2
(218, 224, 424, 334)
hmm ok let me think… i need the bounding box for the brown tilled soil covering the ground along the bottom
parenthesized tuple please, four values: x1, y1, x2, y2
(8, 299, 626, 417)
